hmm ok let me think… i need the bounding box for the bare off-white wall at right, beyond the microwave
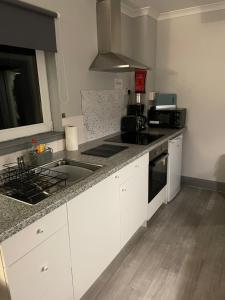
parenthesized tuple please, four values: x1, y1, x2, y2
(156, 10, 225, 182)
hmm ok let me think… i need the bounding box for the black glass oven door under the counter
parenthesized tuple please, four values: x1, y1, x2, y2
(148, 153, 168, 203)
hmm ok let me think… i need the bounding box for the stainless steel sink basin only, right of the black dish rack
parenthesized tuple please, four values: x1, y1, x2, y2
(45, 159, 102, 183)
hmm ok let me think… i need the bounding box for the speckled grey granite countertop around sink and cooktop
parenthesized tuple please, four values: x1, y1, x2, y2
(0, 129, 183, 243)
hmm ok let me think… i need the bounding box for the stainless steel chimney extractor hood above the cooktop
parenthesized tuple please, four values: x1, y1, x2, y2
(90, 0, 150, 73)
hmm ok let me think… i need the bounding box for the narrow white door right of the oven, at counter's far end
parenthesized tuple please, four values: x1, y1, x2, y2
(168, 135, 183, 201)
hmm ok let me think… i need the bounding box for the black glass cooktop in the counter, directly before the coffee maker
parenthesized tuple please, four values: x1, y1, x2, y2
(106, 132, 163, 145)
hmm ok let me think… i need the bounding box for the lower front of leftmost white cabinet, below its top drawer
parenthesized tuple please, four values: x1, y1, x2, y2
(7, 226, 73, 300)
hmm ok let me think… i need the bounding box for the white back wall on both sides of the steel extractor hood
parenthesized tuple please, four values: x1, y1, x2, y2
(22, 0, 156, 117)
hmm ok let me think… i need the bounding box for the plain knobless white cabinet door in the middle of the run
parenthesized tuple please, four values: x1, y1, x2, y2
(68, 175, 120, 299)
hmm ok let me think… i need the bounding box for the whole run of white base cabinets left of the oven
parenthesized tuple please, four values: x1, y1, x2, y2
(0, 154, 149, 300)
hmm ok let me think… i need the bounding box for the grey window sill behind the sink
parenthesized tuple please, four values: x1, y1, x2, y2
(0, 131, 65, 156)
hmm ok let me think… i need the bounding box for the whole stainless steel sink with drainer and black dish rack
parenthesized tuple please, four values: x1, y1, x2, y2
(0, 159, 103, 205)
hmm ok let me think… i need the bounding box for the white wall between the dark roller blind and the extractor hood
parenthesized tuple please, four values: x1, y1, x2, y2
(22, 0, 130, 117)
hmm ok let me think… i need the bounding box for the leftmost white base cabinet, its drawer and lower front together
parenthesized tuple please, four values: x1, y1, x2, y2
(1, 205, 73, 300)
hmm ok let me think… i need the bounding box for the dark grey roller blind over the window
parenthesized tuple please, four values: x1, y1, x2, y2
(0, 0, 57, 52)
